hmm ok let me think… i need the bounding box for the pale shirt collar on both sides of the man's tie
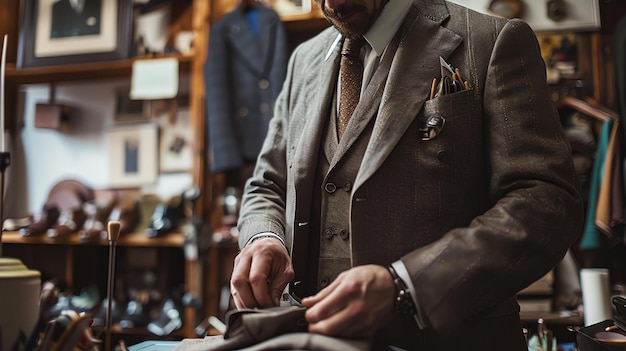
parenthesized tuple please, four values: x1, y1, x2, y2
(324, 0, 413, 60)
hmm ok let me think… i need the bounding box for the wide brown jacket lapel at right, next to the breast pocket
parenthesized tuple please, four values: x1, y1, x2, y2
(354, 1, 462, 189)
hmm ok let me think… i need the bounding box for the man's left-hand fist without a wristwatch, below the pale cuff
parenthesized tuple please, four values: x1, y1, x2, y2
(230, 238, 295, 309)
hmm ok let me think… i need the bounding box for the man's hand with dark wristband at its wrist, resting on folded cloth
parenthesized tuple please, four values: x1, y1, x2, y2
(302, 265, 395, 338)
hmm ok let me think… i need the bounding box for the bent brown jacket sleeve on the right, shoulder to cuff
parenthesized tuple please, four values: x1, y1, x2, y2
(402, 20, 583, 336)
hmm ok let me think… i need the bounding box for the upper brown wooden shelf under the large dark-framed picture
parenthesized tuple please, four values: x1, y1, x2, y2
(6, 55, 194, 84)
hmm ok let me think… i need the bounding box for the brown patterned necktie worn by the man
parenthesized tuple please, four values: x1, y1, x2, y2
(337, 36, 365, 139)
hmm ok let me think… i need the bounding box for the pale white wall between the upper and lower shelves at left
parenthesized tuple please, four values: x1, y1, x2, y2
(6, 78, 192, 217)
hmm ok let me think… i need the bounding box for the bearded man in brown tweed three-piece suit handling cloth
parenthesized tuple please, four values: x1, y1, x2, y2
(231, 0, 583, 351)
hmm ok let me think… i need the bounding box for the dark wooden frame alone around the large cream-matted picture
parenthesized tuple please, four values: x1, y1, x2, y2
(17, 0, 133, 68)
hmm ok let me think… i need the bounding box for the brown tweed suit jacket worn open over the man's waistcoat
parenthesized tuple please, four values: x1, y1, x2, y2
(239, 0, 583, 350)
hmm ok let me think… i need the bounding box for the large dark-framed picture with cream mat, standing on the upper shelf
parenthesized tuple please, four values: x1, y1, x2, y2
(17, 0, 133, 68)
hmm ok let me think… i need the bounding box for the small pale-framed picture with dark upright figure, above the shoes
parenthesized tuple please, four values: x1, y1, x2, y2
(107, 123, 158, 188)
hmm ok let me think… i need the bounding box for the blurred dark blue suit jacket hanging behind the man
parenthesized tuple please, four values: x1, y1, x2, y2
(205, 4, 288, 172)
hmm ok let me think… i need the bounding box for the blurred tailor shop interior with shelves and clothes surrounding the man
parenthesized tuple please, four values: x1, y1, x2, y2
(0, 0, 626, 350)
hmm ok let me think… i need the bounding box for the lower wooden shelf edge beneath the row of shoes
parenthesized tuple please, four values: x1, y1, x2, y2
(2, 232, 185, 248)
